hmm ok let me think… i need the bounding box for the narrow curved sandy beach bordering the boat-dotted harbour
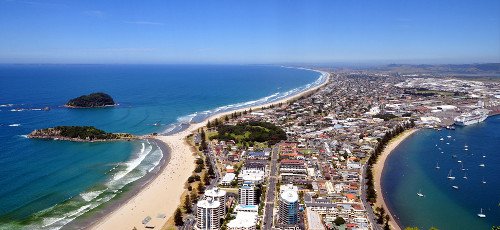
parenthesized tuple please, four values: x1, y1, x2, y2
(373, 129, 418, 230)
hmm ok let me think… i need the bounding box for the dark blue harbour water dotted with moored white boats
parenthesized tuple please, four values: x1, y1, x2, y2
(382, 116, 500, 230)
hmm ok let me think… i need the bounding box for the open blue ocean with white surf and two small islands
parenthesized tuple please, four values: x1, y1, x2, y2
(0, 65, 325, 229)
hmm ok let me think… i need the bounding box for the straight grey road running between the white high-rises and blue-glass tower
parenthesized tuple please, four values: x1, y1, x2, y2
(262, 146, 278, 229)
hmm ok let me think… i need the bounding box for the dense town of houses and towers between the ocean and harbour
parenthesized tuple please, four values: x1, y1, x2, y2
(170, 72, 500, 230)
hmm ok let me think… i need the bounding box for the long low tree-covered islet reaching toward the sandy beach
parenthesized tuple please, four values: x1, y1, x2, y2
(28, 126, 137, 142)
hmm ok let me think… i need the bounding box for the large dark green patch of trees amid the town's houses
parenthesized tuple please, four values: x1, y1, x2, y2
(211, 122, 286, 145)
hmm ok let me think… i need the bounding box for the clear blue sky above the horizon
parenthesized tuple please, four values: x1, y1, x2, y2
(0, 0, 500, 64)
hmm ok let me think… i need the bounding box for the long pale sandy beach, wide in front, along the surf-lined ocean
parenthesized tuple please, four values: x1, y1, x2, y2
(92, 72, 330, 230)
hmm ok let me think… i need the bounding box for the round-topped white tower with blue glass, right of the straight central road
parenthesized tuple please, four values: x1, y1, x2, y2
(278, 185, 299, 225)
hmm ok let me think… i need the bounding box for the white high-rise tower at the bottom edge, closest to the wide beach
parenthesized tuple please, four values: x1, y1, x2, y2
(195, 197, 221, 230)
